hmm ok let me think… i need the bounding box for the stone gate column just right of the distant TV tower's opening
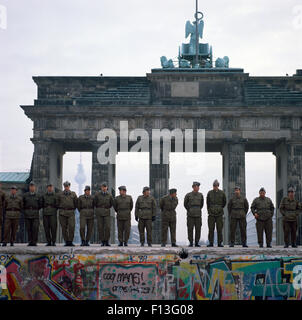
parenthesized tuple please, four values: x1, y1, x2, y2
(91, 145, 116, 243)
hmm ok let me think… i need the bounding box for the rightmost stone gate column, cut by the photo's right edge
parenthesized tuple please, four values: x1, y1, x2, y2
(275, 140, 302, 245)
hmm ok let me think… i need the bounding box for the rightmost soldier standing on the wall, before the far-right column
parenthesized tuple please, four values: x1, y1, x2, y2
(279, 187, 301, 248)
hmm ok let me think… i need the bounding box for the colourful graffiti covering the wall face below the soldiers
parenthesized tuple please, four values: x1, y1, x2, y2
(0, 254, 302, 300)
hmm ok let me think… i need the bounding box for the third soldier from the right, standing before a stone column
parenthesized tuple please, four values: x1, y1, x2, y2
(228, 186, 249, 248)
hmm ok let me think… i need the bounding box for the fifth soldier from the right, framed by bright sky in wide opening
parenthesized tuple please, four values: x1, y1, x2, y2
(184, 182, 204, 247)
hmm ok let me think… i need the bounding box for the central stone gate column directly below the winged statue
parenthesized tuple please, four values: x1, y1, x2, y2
(149, 148, 170, 244)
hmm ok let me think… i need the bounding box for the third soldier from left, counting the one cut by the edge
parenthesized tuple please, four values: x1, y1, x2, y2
(23, 181, 42, 246)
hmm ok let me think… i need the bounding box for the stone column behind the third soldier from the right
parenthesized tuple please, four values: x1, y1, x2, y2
(222, 140, 245, 244)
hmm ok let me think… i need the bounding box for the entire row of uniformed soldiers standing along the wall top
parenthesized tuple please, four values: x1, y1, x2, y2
(0, 180, 302, 248)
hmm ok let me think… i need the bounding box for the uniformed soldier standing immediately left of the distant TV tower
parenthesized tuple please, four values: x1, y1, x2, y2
(58, 181, 78, 247)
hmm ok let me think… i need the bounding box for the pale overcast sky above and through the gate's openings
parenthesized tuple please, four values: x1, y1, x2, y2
(0, 0, 302, 237)
